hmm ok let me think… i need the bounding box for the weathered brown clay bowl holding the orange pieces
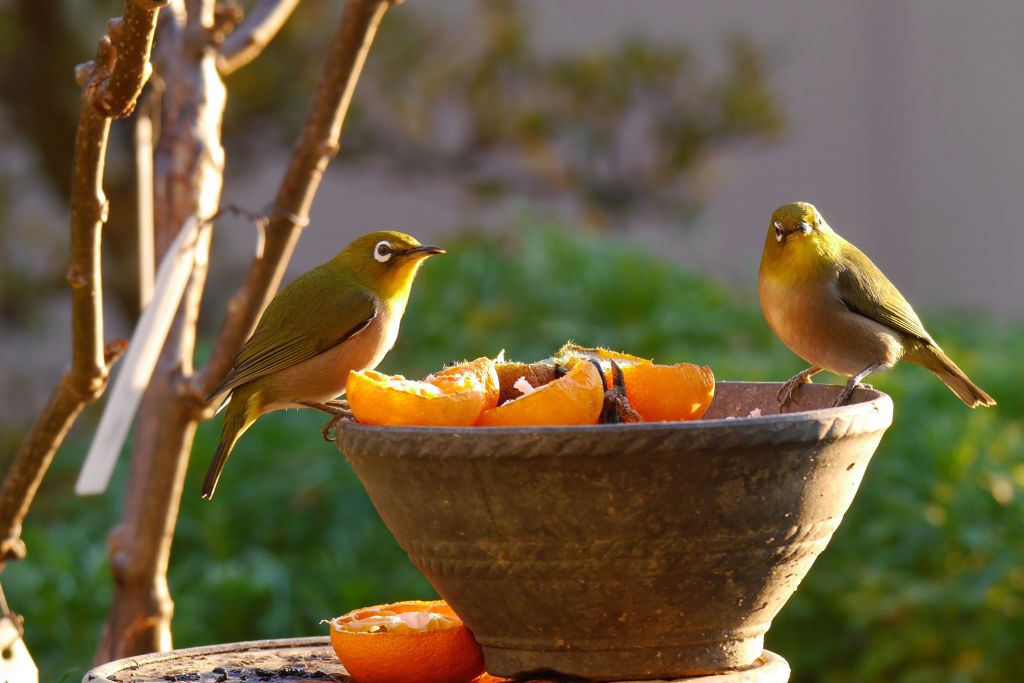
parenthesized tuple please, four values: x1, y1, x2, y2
(338, 382, 892, 680)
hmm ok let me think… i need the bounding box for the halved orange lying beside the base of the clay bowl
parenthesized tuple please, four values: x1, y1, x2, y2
(328, 600, 483, 683)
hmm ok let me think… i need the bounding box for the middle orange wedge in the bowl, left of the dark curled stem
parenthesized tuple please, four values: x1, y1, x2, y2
(476, 360, 604, 427)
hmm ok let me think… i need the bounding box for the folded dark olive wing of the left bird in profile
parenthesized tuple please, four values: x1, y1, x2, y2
(208, 280, 377, 400)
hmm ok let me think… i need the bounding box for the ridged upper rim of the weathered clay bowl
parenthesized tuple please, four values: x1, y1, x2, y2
(336, 380, 893, 450)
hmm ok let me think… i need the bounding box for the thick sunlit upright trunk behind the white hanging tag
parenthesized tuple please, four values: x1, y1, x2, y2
(95, 0, 225, 661)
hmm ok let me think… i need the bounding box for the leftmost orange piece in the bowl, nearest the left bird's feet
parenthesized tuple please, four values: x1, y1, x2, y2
(345, 370, 487, 427)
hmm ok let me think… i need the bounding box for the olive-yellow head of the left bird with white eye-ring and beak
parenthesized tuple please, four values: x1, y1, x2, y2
(335, 230, 444, 298)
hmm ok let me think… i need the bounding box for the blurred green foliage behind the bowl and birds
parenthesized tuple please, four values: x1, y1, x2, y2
(3, 226, 1024, 683)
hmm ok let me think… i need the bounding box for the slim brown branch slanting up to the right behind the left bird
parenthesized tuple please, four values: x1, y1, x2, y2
(196, 0, 393, 396)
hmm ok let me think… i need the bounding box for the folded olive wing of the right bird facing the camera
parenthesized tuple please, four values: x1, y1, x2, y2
(837, 243, 935, 344)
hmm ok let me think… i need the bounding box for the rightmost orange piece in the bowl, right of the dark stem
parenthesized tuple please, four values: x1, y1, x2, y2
(608, 362, 715, 422)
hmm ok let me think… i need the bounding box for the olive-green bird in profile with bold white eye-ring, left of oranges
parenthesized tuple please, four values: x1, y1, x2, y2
(203, 230, 444, 499)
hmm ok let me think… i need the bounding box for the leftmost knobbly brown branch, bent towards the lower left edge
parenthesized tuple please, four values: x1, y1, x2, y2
(0, 0, 168, 573)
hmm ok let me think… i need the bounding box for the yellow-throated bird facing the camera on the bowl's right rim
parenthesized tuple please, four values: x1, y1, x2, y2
(758, 202, 995, 408)
